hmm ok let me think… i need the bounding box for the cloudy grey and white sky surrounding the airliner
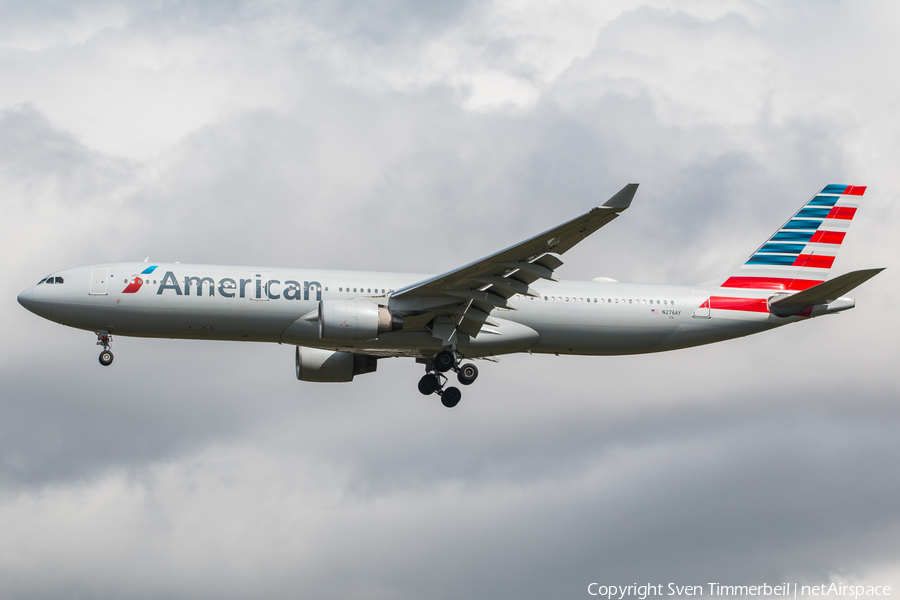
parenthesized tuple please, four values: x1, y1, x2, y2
(0, 0, 900, 599)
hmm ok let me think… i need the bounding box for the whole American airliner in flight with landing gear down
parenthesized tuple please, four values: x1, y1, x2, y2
(18, 183, 883, 408)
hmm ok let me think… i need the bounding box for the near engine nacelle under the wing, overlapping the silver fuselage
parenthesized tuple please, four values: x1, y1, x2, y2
(319, 300, 403, 342)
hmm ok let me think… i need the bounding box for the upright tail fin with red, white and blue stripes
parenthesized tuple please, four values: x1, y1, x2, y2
(722, 184, 866, 291)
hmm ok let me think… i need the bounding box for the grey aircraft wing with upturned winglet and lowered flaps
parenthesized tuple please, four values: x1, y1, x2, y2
(389, 183, 638, 343)
